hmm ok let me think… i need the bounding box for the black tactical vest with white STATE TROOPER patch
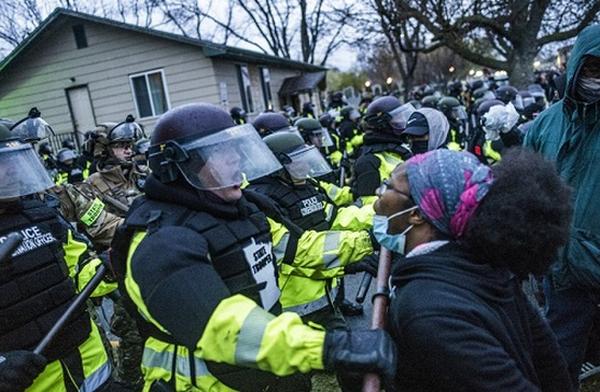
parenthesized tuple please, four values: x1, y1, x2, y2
(111, 197, 281, 390)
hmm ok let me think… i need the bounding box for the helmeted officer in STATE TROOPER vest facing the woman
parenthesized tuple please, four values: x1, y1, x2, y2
(113, 104, 394, 391)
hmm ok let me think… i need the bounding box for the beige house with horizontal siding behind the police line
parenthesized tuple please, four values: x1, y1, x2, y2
(0, 8, 327, 147)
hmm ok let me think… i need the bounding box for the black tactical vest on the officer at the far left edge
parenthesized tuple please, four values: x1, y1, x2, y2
(0, 200, 91, 362)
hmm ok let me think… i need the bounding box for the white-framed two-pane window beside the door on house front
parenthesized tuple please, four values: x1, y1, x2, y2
(129, 70, 169, 118)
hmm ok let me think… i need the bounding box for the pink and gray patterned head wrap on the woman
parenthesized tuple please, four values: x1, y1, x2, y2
(406, 149, 493, 238)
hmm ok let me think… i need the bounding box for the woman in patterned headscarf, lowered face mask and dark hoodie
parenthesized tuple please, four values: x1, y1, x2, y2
(374, 149, 572, 392)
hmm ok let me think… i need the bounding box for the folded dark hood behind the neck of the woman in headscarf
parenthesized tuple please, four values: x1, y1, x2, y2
(391, 242, 514, 303)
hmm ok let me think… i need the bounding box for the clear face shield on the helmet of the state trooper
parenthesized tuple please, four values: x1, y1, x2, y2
(175, 124, 281, 190)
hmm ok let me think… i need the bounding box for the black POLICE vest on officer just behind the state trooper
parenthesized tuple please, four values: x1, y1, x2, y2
(251, 178, 332, 231)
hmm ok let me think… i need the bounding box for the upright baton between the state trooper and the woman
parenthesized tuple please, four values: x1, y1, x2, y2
(362, 246, 392, 392)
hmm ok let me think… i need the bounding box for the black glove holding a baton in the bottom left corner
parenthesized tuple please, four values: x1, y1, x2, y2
(0, 351, 46, 392)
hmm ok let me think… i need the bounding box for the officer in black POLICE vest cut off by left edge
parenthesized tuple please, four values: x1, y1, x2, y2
(0, 128, 115, 391)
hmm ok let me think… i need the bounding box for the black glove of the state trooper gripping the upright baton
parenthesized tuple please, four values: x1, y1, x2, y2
(323, 329, 397, 385)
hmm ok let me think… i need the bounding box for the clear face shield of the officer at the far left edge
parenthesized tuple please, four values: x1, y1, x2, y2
(0, 141, 54, 200)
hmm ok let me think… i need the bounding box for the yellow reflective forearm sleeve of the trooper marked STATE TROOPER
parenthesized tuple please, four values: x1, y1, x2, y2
(198, 294, 325, 376)
